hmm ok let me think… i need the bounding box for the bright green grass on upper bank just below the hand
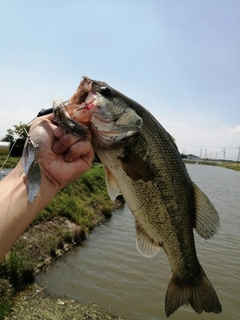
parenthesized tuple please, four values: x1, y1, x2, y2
(34, 165, 113, 230)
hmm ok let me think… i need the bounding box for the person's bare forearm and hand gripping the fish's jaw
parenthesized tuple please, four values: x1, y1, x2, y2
(0, 115, 94, 261)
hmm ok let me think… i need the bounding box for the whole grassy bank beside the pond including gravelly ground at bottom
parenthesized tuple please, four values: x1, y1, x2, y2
(0, 165, 124, 320)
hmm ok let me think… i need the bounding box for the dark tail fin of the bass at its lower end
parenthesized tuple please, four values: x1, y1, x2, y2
(165, 268, 222, 317)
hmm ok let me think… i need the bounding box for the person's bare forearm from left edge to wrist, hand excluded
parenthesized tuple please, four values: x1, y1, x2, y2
(0, 163, 57, 261)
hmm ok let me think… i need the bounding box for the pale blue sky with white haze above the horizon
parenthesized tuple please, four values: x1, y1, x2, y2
(0, 0, 240, 160)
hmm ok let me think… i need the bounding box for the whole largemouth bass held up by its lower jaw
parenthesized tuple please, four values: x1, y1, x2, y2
(52, 77, 222, 317)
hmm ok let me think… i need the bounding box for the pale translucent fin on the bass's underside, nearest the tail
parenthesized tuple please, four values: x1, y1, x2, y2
(136, 222, 160, 258)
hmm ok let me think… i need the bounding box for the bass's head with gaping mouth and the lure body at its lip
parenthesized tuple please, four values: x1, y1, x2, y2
(53, 77, 142, 147)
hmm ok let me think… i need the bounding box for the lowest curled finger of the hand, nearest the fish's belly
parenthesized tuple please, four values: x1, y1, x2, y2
(64, 140, 94, 162)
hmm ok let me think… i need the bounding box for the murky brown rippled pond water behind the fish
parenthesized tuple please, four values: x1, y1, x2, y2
(37, 165, 240, 320)
